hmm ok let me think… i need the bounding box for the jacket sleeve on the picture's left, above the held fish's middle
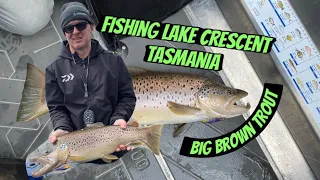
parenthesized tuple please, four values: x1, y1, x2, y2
(45, 64, 73, 132)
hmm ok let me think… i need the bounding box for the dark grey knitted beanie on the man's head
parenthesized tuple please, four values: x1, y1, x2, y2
(60, 2, 94, 28)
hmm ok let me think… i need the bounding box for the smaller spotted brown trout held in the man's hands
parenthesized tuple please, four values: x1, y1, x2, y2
(27, 123, 163, 178)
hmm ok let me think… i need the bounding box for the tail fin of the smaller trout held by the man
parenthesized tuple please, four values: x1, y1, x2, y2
(142, 124, 163, 155)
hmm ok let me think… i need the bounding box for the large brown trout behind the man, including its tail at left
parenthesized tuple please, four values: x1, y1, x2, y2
(17, 64, 251, 135)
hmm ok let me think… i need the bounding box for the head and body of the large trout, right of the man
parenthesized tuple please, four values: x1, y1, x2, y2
(127, 67, 250, 136)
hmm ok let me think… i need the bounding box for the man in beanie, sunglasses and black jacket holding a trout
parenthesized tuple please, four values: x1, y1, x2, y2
(46, 2, 136, 156)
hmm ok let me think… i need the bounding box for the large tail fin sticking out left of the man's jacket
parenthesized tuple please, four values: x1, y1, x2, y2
(16, 63, 49, 122)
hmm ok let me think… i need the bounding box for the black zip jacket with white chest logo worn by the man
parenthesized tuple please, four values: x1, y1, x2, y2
(45, 40, 136, 131)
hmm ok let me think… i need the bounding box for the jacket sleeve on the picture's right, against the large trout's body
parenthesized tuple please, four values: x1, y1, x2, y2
(110, 56, 137, 124)
